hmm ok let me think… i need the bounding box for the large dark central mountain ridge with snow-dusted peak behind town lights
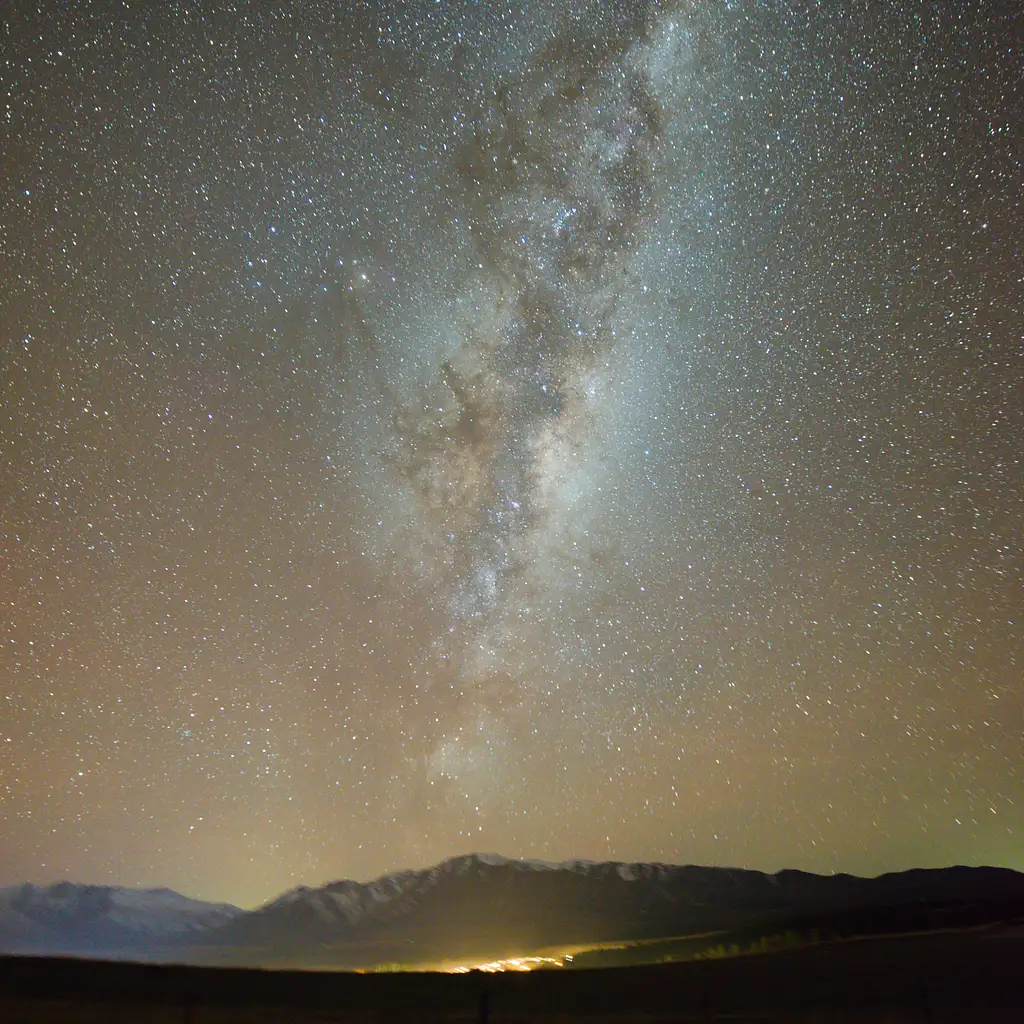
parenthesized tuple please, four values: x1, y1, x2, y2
(193, 854, 1024, 966)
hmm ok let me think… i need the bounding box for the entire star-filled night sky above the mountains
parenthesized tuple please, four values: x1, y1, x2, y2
(0, 0, 1024, 906)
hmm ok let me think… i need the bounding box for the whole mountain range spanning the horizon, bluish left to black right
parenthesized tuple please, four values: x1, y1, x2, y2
(0, 854, 1024, 967)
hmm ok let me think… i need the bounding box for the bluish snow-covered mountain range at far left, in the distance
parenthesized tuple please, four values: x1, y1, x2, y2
(0, 882, 243, 953)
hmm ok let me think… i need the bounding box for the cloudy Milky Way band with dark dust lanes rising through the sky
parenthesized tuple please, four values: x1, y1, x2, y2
(382, 8, 684, 786)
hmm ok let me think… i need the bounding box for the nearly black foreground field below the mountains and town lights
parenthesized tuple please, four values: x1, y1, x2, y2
(0, 927, 1024, 1024)
